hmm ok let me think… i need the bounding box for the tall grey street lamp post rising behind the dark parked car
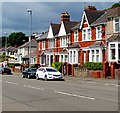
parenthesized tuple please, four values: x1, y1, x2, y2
(27, 9, 32, 67)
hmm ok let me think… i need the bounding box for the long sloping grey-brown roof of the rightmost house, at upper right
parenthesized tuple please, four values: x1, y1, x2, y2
(91, 7, 120, 26)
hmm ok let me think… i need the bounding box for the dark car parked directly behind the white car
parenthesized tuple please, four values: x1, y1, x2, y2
(22, 68, 37, 79)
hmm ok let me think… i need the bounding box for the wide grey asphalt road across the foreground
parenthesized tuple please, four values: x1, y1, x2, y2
(2, 74, 119, 111)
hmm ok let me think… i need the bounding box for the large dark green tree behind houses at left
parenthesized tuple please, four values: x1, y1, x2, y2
(8, 32, 28, 47)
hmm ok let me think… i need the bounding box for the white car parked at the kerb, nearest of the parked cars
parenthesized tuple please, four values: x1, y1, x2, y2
(36, 67, 64, 81)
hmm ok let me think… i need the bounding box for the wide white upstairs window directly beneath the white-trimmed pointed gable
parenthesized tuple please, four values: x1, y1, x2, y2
(82, 27, 91, 41)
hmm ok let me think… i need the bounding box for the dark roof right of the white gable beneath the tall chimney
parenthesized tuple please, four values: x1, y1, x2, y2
(63, 21, 79, 34)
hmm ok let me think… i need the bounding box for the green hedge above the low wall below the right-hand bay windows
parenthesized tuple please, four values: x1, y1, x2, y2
(85, 62, 102, 70)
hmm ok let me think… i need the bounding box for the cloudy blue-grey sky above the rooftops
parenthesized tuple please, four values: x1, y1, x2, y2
(0, 2, 115, 36)
